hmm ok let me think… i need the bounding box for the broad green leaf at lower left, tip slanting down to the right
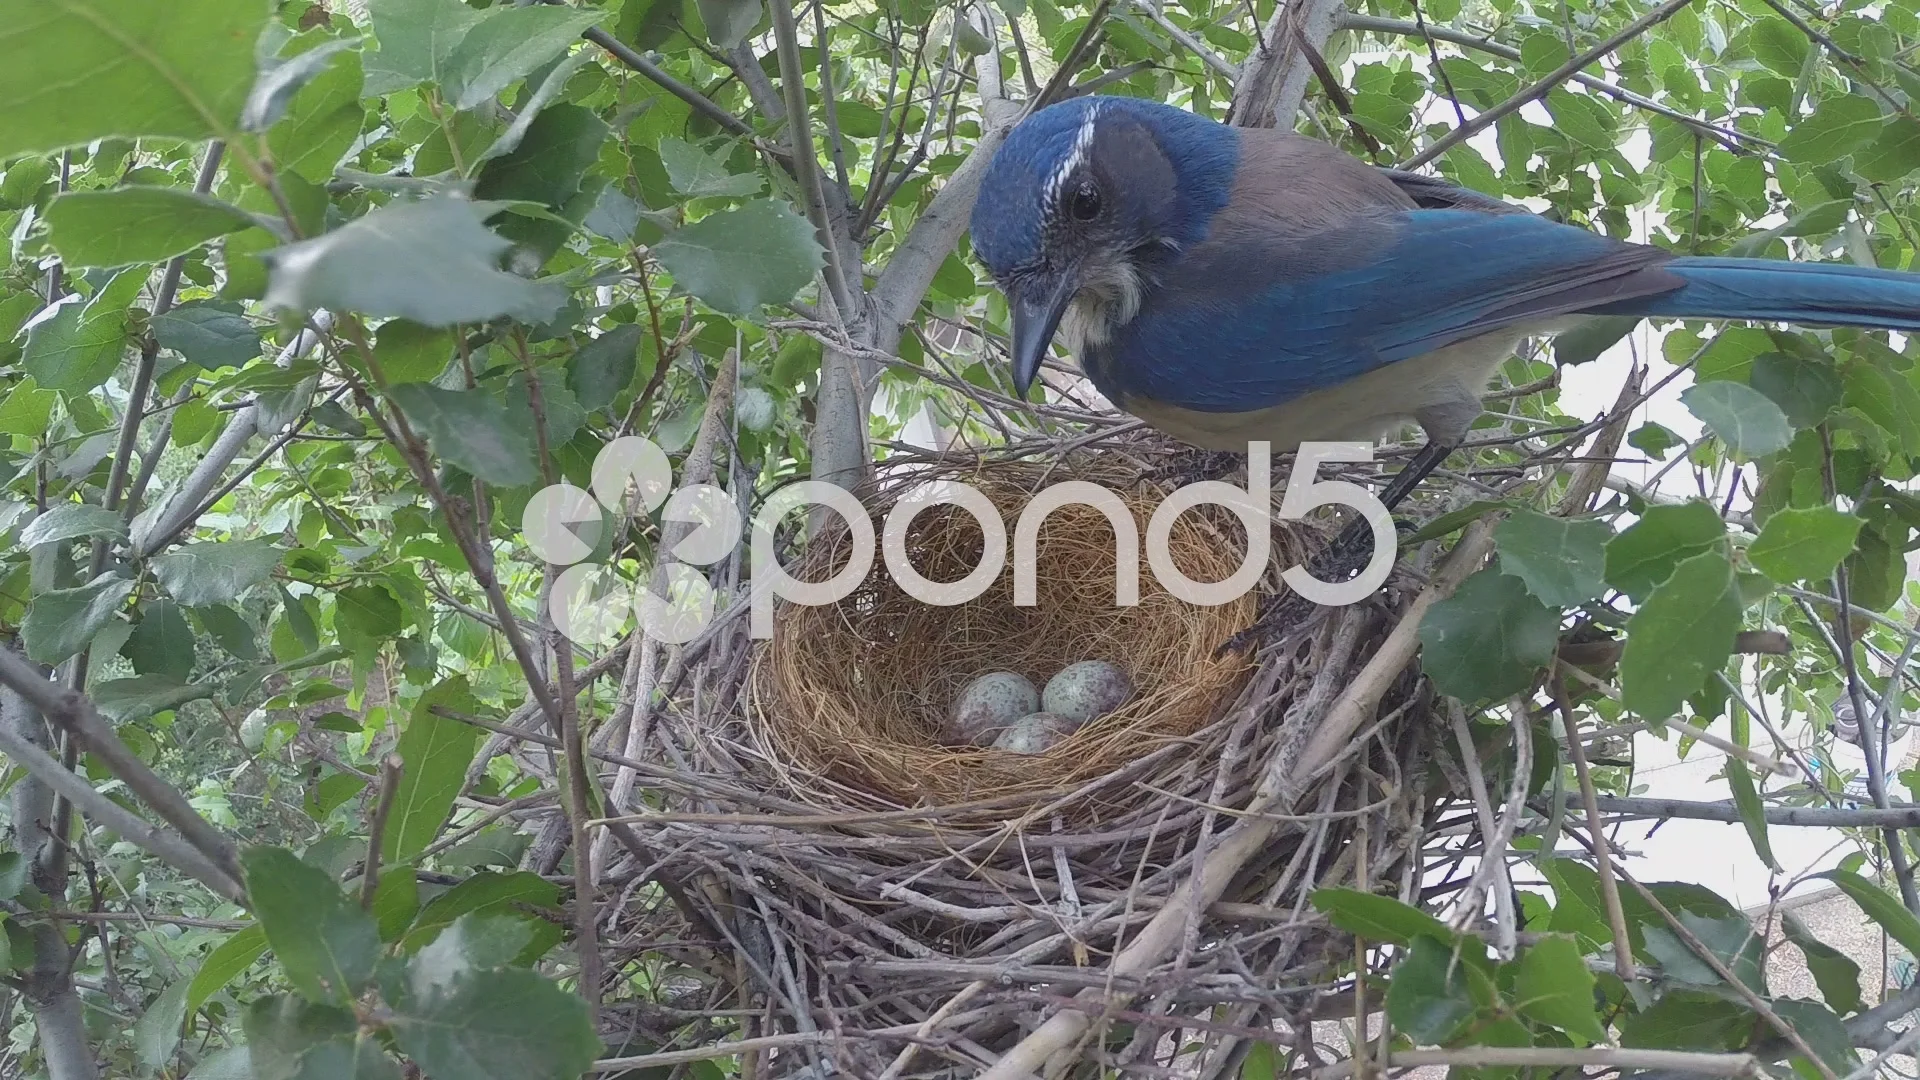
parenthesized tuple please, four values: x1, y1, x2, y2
(242, 847, 380, 1005)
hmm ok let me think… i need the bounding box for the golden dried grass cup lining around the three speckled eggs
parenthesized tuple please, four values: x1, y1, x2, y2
(751, 455, 1304, 809)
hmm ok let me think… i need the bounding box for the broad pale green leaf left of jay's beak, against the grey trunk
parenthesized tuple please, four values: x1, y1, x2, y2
(653, 200, 824, 315)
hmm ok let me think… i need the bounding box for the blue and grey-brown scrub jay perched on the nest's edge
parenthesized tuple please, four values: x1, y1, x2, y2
(972, 96, 1920, 532)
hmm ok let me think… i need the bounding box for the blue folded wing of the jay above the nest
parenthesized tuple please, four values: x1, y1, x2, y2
(1092, 209, 1684, 413)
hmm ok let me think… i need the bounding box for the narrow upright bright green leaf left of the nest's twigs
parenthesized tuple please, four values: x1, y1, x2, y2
(384, 675, 480, 863)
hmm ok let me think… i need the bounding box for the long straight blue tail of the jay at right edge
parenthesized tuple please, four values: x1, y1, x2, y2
(1607, 256, 1920, 331)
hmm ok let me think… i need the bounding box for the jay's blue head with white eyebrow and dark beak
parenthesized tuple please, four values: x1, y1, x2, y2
(972, 96, 1240, 396)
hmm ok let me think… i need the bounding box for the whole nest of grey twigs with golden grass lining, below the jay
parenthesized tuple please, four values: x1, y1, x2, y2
(603, 434, 1444, 1080)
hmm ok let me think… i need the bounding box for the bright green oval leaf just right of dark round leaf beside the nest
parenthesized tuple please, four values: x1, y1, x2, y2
(1620, 552, 1743, 721)
